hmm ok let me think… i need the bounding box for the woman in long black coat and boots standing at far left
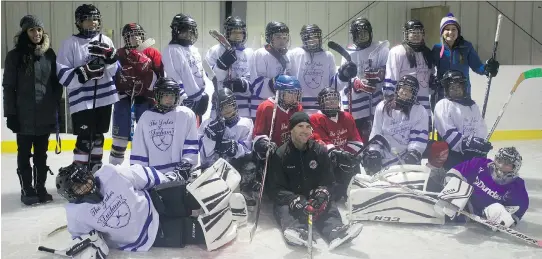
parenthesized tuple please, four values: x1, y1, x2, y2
(2, 15, 63, 205)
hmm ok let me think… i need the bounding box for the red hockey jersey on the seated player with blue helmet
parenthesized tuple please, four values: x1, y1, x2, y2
(254, 98, 303, 147)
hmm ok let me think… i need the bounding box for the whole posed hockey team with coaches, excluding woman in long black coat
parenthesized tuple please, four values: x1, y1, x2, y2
(4, 4, 528, 258)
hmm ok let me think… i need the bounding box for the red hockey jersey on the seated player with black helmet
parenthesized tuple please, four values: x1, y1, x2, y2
(310, 111, 363, 154)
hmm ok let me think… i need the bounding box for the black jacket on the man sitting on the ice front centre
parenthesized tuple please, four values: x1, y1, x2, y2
(269, 139, 335, 206)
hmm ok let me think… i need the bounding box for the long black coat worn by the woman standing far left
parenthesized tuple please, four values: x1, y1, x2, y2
(2, 33, 63, 135)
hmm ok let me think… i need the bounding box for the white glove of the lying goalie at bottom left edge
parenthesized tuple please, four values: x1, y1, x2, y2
(66, 230, 109, 259)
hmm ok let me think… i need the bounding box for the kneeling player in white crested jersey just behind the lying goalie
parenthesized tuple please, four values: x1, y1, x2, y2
(130, 77, 199, 174)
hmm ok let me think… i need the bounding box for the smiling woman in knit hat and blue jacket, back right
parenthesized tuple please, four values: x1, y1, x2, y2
(432, 13, 499, 101)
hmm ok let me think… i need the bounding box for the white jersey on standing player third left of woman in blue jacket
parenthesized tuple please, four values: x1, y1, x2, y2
(286, 47, 337, 116)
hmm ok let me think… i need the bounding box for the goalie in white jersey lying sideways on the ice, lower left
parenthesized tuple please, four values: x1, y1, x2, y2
(56, 160, 246, 259)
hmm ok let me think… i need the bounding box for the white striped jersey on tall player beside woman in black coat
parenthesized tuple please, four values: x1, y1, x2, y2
(56, 34, 120, 114)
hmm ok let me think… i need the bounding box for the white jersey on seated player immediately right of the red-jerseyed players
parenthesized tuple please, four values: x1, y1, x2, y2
(369, 102, 429, 167)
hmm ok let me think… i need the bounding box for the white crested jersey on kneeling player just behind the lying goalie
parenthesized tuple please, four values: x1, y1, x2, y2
(130, 106, 199, 172)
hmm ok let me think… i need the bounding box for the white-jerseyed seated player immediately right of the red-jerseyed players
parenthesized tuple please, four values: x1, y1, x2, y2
(362, 75, 429, 175)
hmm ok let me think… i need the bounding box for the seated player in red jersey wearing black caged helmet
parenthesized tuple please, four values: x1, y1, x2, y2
(310, 87, 363, 200)
